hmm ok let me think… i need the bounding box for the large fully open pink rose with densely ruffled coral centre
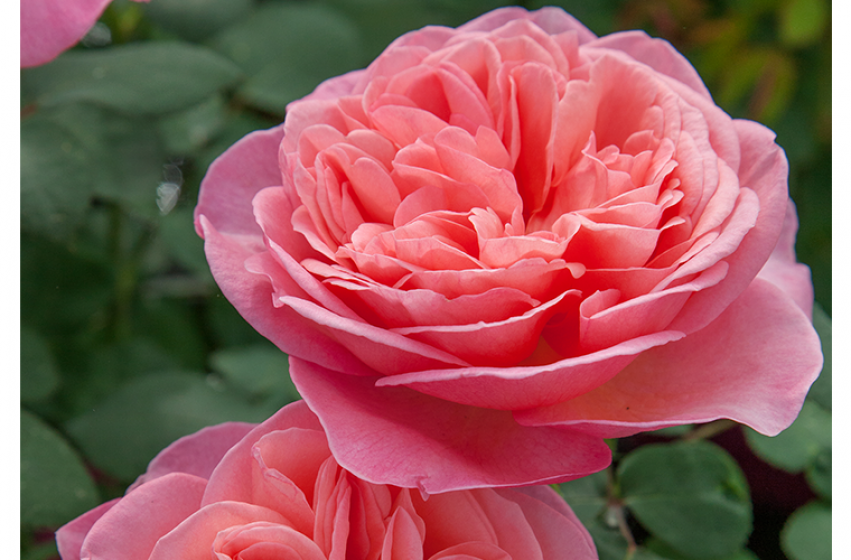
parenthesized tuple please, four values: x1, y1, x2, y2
(196, 8, 822, 492)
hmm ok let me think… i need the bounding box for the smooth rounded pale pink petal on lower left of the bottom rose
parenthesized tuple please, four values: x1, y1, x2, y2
(80, 473, 207, 560)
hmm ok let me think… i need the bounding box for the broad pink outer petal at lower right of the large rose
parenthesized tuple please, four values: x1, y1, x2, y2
(515, 279, 822, 438)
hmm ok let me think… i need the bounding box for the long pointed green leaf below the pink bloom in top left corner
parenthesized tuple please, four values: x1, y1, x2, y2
(21, 41, 241, 115)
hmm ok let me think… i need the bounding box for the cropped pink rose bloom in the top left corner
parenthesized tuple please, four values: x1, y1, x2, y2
(21, 0, 148, 67)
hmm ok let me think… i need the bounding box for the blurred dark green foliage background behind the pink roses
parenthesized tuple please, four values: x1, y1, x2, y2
(21, 0, 832, 560)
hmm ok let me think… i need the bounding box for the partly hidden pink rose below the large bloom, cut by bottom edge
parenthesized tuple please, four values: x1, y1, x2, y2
(56, 401, 597, 560)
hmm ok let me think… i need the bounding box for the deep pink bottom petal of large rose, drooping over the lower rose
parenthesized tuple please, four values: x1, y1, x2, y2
(290, 356, 611, 494)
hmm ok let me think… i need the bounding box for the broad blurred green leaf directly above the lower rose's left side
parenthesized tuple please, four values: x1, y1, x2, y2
(67, 372, 267, 482)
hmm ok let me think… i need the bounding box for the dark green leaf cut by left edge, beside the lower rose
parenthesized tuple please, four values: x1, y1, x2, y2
(21, 410, 99, 527)
